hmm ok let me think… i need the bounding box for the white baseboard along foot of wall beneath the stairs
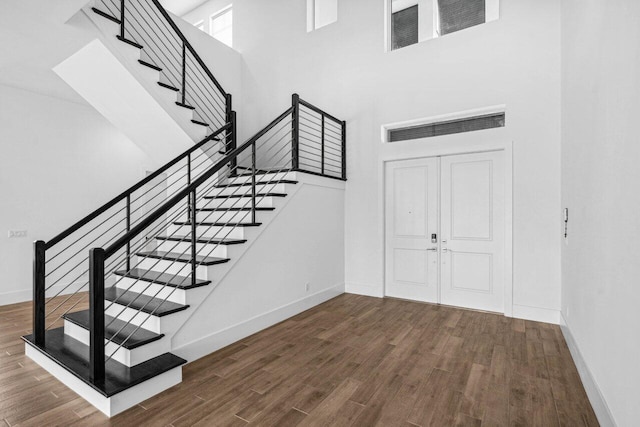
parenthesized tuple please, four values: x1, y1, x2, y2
(172, 283, 344, 362)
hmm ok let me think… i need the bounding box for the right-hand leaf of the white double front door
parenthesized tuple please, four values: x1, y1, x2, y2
(440, 152, 504, 312)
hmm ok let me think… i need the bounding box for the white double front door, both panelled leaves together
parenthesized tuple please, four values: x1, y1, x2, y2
(385, 151, 505, 312)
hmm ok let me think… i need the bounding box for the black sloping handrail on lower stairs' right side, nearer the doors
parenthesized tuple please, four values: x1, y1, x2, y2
(104, 107, 294, 259)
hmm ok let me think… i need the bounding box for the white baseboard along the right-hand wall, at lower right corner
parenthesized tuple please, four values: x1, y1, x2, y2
(560, 313, 616, 427)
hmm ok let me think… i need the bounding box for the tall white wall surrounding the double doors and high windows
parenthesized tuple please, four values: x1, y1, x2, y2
(222, 0, 561, 321)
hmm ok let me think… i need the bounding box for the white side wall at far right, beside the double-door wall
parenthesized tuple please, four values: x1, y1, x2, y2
(562, 0, 640, 426)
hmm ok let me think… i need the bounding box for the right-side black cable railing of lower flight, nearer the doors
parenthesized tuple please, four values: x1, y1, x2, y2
(89, 107, 293, 380)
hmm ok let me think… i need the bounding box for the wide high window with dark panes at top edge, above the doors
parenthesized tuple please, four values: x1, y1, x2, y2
(387, 0, 500, 50)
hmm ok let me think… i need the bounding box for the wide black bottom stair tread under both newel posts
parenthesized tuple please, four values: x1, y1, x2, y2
(22, 328, 187, 397)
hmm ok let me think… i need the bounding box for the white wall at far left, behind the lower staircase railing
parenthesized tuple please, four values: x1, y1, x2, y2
(0, 86, 157, 305)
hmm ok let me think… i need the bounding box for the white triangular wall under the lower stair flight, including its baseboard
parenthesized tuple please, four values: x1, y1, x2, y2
(170, 172, 345, 361)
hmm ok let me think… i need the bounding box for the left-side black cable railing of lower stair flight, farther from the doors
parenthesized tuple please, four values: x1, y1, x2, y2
(34, 123, 234, 346)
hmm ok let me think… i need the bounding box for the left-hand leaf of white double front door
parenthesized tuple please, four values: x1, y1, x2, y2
(385, 158, 439, 302)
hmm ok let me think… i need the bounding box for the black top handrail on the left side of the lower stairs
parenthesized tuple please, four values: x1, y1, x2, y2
(45, 123, 232, 249)
